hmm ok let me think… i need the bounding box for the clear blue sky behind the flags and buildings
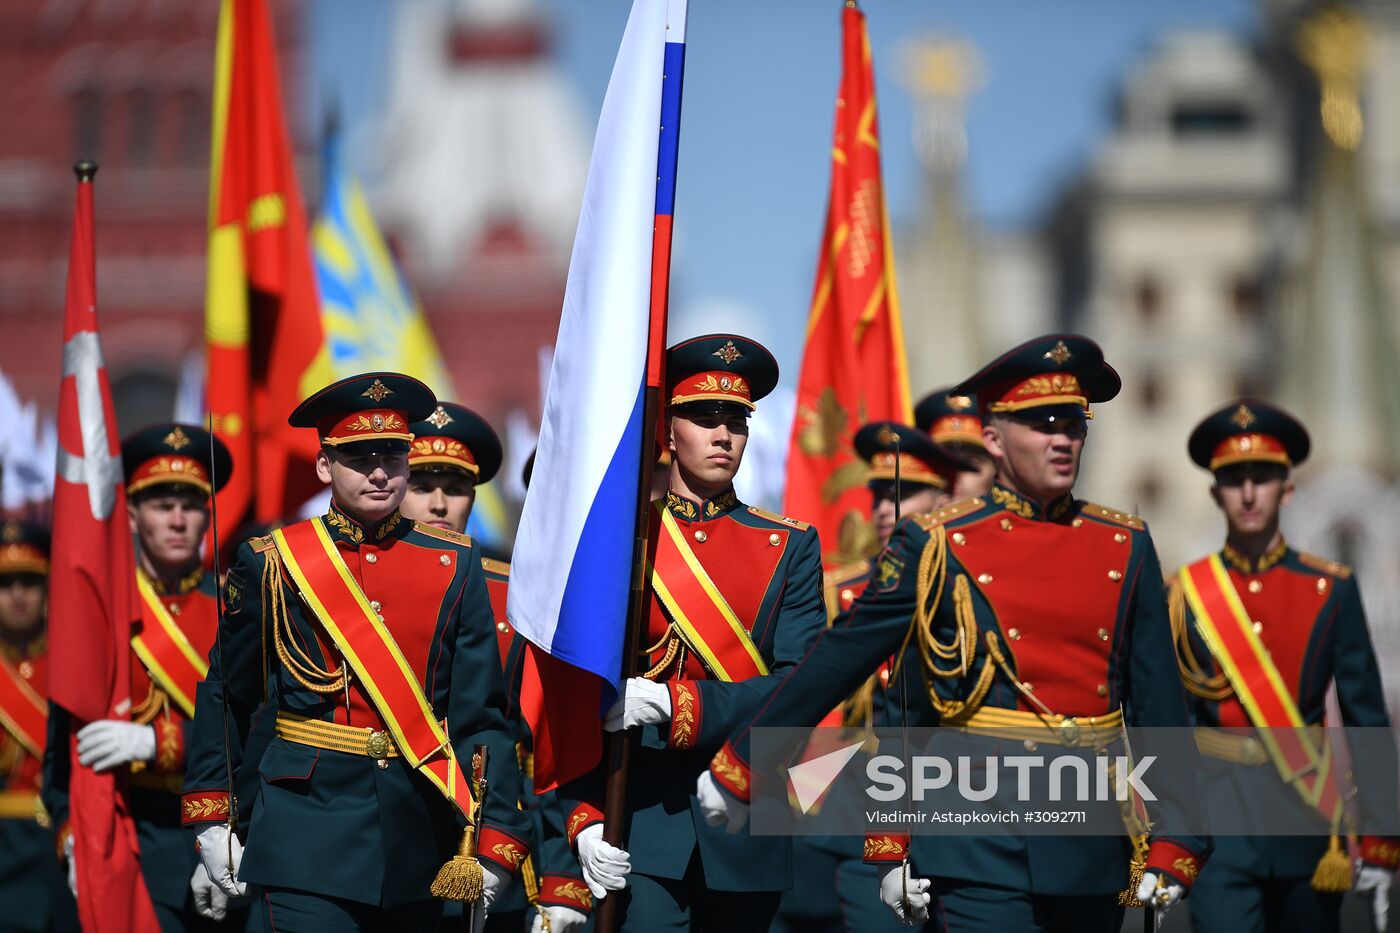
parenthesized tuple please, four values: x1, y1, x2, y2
(312, 0, 1257, 385)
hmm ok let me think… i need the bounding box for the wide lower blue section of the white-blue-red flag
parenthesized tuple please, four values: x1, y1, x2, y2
(549, 378, 643, 689)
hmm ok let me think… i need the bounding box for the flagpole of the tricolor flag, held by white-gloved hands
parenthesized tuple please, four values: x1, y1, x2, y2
(595, 0, 686, 933)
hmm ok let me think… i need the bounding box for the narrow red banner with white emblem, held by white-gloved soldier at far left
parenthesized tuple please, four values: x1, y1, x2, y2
(49, 163, 160, 933)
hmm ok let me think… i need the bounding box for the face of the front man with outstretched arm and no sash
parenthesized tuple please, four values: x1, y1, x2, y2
(981, 409, 1088, 503)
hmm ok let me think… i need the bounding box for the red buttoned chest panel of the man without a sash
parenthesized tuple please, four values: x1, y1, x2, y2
(949, 513, 1131, 716)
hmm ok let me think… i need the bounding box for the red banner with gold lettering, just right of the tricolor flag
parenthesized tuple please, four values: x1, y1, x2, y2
(783, 6, 910, 567)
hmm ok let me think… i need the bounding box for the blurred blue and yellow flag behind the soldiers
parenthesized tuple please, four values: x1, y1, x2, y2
(311, 132, 456, 399)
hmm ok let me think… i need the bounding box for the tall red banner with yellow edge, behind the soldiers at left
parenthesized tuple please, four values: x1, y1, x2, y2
(204, 0, 333, 530)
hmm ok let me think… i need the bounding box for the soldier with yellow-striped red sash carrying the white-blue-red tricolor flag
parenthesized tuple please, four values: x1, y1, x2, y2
(566, 333, 830, 933)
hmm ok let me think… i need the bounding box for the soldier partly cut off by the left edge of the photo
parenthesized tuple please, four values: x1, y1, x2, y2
(0, 521, 78, 933)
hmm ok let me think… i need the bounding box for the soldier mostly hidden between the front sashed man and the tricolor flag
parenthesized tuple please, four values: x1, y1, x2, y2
(402, 402, 592, 933)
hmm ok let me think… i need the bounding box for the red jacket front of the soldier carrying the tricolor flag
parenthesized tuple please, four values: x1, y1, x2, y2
(645, 514, 790, 679)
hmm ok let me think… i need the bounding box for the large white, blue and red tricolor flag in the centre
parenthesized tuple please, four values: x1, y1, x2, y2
(505, 0, 686, 793)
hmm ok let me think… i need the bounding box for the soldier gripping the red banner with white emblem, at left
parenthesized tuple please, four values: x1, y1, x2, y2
(45, 423, 240, 933)
